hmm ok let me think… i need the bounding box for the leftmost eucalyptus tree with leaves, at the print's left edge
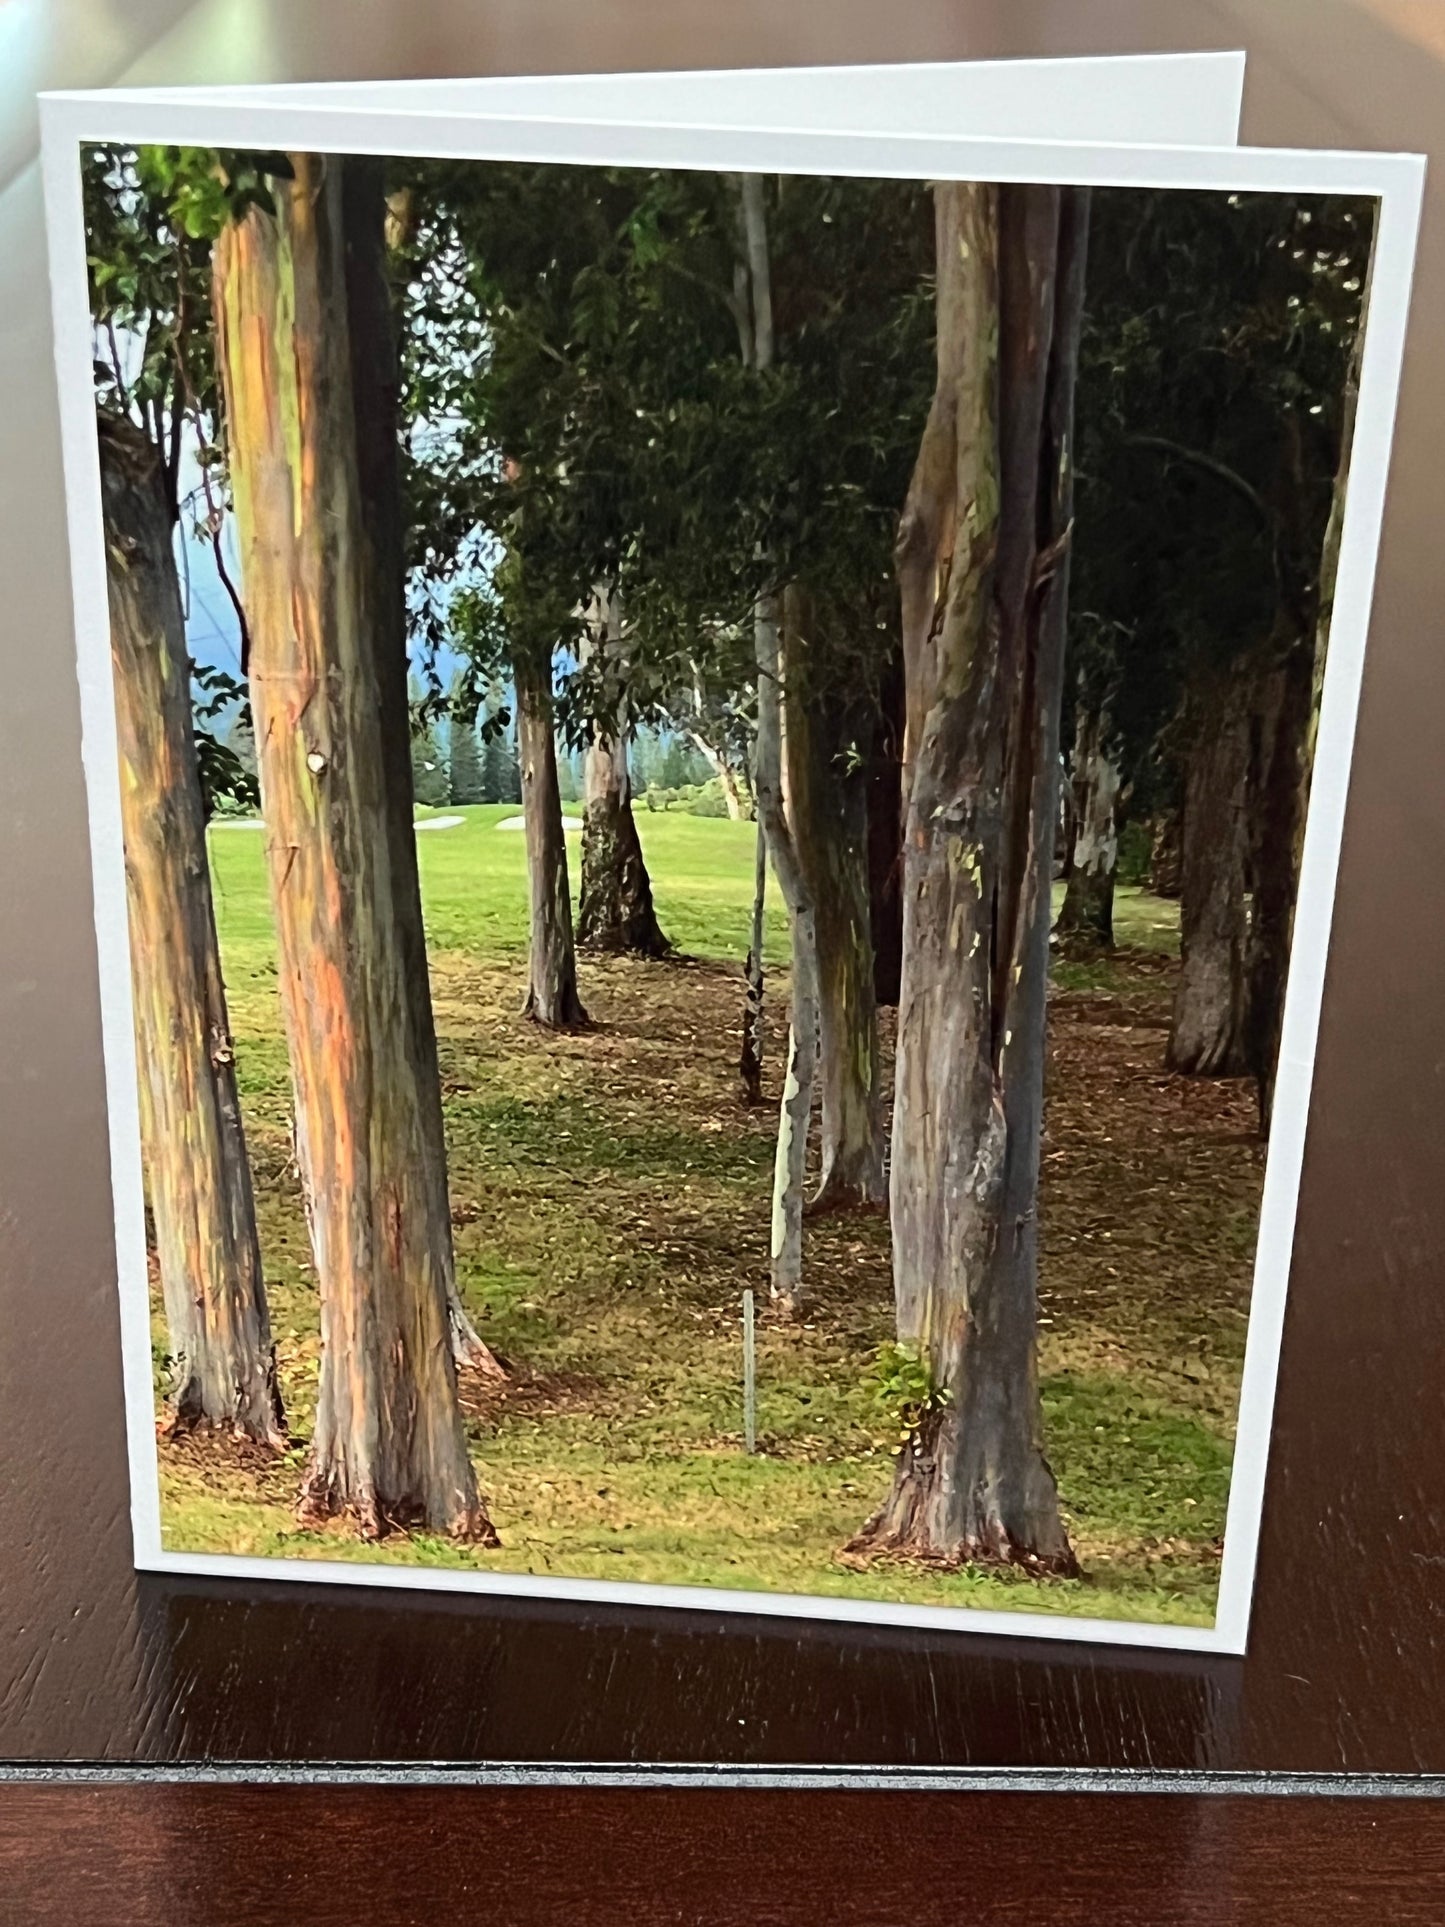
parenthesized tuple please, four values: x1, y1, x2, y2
(83, 148, 285, 1447)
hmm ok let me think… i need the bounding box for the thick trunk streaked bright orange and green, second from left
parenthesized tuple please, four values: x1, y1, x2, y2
(214, 154, 495, 1542)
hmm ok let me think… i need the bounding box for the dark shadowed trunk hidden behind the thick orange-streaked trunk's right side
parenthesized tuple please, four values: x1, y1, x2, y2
(339, 154, 505, 1378)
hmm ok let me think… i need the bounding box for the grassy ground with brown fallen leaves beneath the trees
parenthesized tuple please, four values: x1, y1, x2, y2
(154, 807, 1264, 1624)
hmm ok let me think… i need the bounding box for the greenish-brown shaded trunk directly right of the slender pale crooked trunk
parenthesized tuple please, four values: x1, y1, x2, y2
(784, 655, 886, 1214)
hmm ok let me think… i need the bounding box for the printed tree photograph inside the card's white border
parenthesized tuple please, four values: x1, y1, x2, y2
(81, 143, 1376, 1630)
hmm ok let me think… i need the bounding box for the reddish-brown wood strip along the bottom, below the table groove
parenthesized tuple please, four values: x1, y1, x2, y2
(0, 1784, 1445, 1927)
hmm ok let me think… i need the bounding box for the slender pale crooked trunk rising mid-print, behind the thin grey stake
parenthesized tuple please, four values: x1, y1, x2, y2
(738, 173, 819, 1312)
